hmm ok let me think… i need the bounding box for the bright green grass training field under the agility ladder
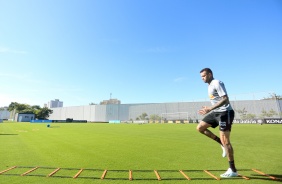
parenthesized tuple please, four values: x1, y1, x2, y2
(0, 122, 282, 184)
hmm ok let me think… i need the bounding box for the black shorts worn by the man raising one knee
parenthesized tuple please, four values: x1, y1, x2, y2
(202, 110, 235, 131)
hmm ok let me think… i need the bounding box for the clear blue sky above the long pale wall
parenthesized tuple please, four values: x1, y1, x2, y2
(0, 0, 282, 107)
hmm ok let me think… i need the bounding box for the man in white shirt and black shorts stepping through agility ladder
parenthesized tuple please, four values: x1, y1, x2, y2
(197, 68, 238, 178)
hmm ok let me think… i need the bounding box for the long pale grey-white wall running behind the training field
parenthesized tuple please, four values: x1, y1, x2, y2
(49, 100, 282, 122)
